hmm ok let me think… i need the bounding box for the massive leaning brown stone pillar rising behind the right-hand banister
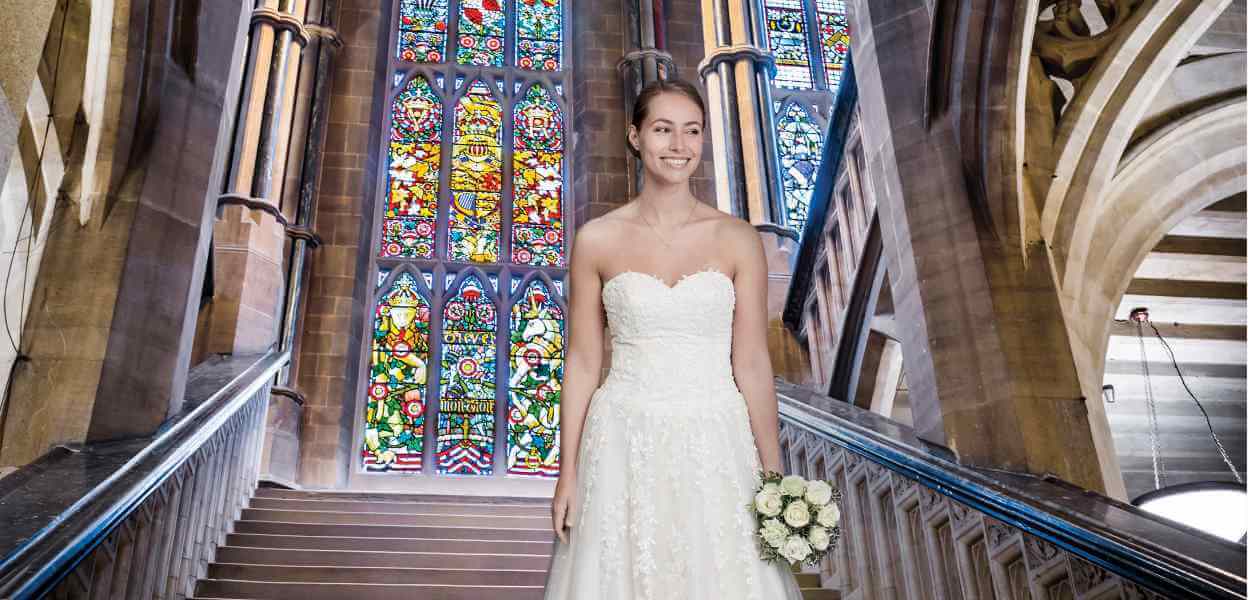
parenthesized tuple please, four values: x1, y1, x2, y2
(850, 0, 1107, 490)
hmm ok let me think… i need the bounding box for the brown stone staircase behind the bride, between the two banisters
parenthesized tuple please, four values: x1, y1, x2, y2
(195, 488, 840, 600)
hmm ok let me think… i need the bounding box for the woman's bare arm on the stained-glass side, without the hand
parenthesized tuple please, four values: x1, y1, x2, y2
(559, 221, 605, 475)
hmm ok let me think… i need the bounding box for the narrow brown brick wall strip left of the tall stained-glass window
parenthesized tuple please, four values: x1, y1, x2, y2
(296, 0, 384, 486)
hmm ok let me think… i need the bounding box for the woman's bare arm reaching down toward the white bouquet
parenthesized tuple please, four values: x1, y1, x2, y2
(725, 218, 781, 472)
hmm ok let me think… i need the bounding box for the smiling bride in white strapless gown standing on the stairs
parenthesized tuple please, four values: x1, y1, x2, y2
(545, 80, 801, 600)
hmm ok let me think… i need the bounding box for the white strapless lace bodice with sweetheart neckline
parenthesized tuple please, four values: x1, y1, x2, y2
(603, 269, 736, 402)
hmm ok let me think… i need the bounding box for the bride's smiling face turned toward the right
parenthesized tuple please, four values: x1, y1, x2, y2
(629, 92, 703, 185)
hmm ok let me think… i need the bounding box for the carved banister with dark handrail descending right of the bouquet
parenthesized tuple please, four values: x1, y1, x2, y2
(776, 382, 1248, 600)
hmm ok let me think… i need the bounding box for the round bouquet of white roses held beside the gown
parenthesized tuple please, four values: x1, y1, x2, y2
(750, 472, 841, 565)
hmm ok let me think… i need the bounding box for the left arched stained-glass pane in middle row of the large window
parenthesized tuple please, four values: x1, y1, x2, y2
(381, 76, 442, 258)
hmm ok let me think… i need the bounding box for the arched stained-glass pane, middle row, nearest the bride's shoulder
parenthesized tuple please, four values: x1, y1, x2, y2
(512, 85, 564, 266)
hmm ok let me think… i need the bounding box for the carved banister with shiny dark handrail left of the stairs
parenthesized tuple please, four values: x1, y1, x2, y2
(0, 353, 290, 599)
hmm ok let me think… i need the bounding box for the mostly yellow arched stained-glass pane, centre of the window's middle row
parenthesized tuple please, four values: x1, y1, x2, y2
(448, 80, 503, 262)
